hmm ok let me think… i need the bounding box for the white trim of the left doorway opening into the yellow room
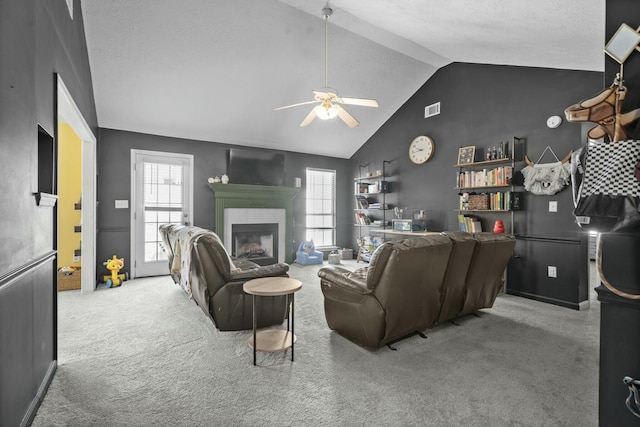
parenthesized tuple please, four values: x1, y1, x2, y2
(56, 74, 97, 292)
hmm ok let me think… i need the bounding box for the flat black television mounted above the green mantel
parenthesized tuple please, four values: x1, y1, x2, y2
(227, 148, 284, 187)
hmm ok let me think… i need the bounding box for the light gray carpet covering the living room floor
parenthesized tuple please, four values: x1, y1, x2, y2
(33, 263, 600, 427)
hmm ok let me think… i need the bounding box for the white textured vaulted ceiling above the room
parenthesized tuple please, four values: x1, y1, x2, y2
(81, 0, 605, 158)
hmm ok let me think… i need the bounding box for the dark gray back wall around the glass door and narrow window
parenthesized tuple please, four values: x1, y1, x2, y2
(97, 129, 352, 277)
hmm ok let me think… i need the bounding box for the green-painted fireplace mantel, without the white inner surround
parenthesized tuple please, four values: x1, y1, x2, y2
(209, 183, 300, 263)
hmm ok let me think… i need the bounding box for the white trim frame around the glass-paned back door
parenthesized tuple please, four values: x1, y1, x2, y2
(129, 148, 195, 279)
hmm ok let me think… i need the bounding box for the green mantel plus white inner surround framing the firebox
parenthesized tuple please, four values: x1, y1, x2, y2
(209, 183, 300, 264)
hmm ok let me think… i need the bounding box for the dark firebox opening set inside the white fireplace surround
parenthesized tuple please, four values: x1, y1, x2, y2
(231, 223, 278, 265)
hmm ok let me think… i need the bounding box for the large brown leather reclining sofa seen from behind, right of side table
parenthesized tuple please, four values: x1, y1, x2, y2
(318, 232, 516, 348)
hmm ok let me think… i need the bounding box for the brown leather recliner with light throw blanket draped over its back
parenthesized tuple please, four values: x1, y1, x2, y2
(160, 224, 289, 331)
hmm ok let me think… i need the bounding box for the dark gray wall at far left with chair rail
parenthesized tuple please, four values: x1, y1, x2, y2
(0, 0, 97, 426)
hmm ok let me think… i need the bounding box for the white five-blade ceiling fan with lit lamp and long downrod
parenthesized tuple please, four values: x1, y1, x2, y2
(275, 7, 378, 128)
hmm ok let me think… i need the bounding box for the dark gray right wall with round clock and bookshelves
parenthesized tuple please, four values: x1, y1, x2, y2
(351, 63, 603, 308)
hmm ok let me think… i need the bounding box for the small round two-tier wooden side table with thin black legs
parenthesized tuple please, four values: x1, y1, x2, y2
(242, 277, 302, 366)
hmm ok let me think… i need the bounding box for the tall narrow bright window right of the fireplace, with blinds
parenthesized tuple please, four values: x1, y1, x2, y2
(306, 168, 336, 247)
